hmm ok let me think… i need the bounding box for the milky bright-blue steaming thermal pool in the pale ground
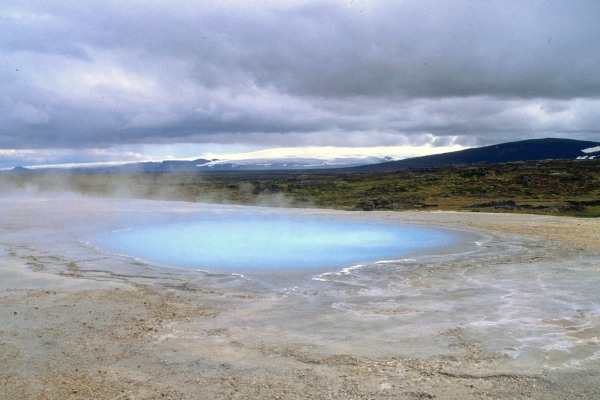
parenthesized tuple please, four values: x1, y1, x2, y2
(95, 214, 456, 272)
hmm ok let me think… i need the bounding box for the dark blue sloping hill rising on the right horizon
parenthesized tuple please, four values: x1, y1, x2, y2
(344, 139, 600, 172)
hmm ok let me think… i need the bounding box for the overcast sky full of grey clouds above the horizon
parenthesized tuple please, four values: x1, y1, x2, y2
(0, 0, 600, 168)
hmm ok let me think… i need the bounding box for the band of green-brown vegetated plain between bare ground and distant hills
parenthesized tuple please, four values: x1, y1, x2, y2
(0, 160, 600, 217)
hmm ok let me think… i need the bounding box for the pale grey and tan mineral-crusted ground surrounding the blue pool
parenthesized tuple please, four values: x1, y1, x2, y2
(0, 196, 600, 400)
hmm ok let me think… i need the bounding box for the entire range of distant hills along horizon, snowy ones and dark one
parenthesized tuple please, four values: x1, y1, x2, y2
(5, 139, 600, 173)
